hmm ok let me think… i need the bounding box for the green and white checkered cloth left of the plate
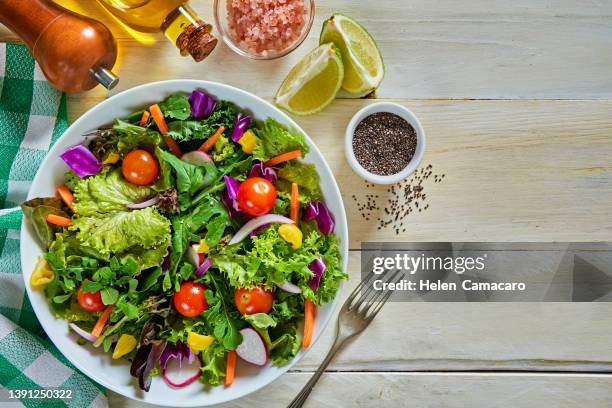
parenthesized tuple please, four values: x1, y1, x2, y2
(0, 44, 108, 408)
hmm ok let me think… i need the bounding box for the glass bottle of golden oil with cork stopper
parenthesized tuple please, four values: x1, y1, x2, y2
(98, 0, 217, 62)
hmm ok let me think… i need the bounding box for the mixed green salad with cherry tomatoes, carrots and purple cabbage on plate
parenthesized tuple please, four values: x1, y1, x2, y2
(22, 89, 347, 391)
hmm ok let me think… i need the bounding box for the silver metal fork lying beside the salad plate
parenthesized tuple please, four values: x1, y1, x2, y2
(288, 270, 402, 408)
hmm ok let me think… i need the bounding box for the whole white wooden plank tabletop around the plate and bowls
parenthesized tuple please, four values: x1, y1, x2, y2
(0, 0, 612, 408)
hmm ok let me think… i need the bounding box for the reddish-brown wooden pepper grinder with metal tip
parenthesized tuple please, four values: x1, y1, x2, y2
(0, 0, 119, 92)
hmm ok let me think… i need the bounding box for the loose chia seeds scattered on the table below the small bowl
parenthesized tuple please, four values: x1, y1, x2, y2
(352, 164, 445, 235)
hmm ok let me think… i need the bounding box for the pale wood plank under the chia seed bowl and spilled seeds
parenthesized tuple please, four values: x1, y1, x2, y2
(69, 96, 612, 249)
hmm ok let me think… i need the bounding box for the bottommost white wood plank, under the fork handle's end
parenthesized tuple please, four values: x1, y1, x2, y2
(108, 373, 612, 408)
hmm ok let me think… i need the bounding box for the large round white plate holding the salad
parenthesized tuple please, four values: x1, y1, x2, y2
(21, 80, 348, 407)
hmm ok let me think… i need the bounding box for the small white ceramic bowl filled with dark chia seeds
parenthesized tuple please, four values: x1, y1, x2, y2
(345, 102, 425, 184)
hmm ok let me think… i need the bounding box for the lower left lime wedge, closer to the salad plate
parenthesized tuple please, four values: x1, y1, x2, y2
(274, 43, 344, 115)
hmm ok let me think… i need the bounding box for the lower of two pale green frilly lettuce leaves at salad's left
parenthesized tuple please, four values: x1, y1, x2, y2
(69, 207, 170, 254)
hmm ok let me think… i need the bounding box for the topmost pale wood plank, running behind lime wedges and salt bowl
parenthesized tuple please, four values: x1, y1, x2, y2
(0, 0, 612, 99)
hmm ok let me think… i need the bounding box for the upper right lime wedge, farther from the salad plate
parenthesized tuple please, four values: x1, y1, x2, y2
(319, 14, 385, 95)
